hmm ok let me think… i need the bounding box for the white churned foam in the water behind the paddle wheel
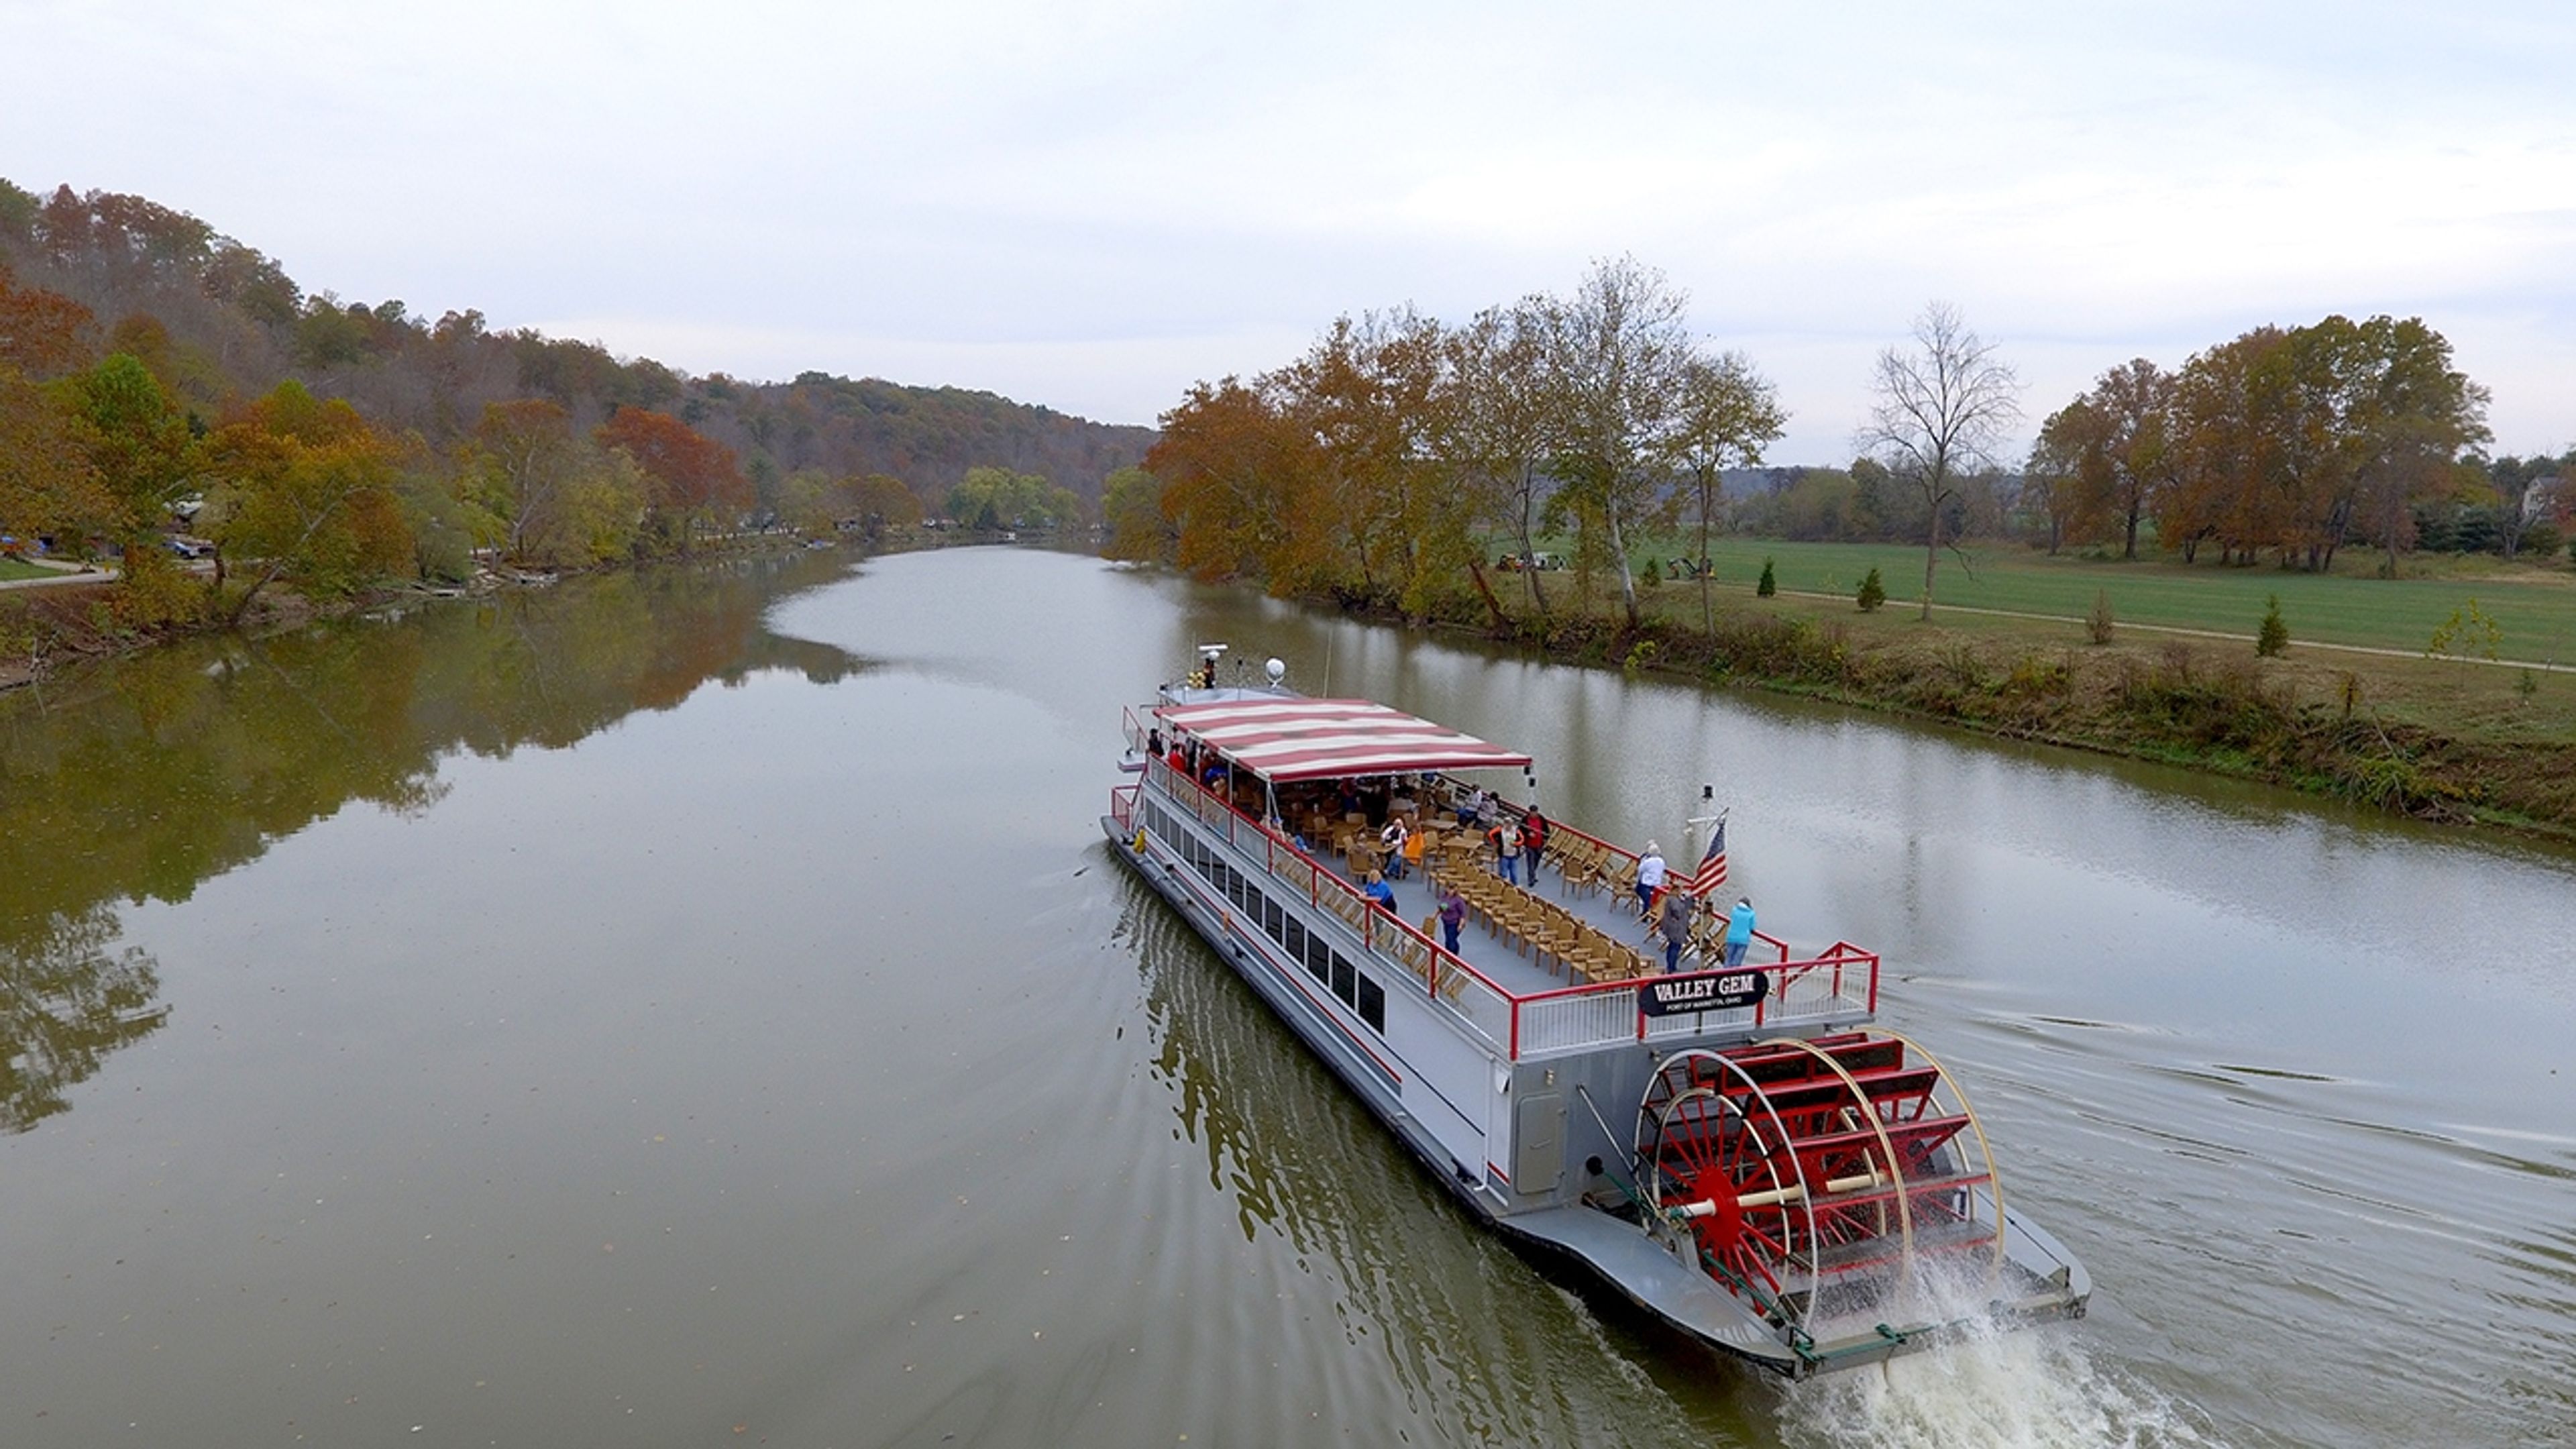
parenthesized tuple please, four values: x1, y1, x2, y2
(1780, 1268, 2220, 1449)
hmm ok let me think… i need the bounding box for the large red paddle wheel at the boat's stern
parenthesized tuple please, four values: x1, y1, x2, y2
(1635, 1031, 2004, 1330)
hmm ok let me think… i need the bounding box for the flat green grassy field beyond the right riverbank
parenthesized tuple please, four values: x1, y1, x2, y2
(1607, 539, 2576, 665)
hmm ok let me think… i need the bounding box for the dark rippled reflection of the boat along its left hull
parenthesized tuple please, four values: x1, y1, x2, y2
(1118, 879, 1744, 1444)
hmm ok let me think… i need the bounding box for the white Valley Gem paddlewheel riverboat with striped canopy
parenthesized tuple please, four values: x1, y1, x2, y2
(1103, 645, 2092, 1377)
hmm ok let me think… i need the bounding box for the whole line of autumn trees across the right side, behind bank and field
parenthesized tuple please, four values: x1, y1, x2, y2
(1103, 258, 2576, 627)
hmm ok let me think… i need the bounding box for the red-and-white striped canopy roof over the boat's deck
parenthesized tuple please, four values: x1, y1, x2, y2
(1154, 696, 1530, 782)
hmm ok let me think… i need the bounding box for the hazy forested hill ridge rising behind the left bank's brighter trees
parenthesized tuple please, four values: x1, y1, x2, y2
(0, 180, 1154, 508)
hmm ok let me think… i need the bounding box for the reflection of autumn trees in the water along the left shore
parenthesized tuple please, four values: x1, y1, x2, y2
(0, 554, 861, 1132)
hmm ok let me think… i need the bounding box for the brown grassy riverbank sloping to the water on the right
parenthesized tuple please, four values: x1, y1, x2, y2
(1311, 580, 2576, 841)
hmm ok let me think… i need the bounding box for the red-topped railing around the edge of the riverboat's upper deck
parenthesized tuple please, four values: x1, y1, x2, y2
(1110, 758, 1878, 1060)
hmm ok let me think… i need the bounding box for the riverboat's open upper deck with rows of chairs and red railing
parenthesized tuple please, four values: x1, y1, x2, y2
(1110, 691, 1878, 1060)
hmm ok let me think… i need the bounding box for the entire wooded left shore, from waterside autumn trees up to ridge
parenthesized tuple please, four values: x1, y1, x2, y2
(0, 180, 1151, 603)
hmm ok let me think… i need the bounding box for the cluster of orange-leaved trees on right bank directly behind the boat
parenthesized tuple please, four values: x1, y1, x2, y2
(1103, 258, 1788, 624)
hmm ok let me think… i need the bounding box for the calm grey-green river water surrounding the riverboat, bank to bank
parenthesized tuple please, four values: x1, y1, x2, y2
(0, 549, 2576, 1449)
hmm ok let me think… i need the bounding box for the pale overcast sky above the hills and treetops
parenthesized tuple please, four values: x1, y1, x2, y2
(15, 0, 2576, 462)
